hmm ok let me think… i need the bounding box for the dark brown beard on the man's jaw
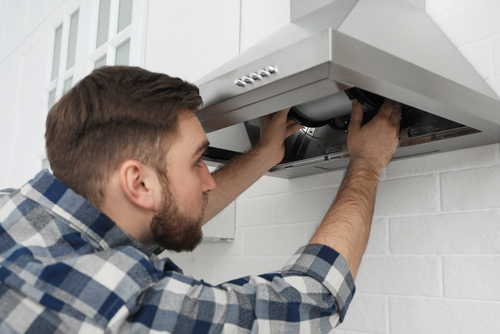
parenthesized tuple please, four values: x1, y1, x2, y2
(151, 185, 208, 253)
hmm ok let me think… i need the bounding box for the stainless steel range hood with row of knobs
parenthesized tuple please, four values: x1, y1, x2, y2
(196, 0, 500, 178)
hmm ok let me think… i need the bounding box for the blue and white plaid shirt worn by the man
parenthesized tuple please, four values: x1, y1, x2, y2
(0, 171, 354, 333)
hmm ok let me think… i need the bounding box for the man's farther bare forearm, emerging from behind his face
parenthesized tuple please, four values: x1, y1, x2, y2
(203, 146, 275, 224)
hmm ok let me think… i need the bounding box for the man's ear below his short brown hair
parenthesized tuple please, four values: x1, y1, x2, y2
(118, 160, 159, 210)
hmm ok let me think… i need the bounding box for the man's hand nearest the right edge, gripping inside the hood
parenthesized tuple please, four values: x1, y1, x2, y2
(347, 99, 401, 175)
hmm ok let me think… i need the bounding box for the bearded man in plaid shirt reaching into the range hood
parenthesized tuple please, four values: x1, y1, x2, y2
(0, 67, 401, 333)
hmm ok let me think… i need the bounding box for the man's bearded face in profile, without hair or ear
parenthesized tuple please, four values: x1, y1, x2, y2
(148, 113, 216, 252)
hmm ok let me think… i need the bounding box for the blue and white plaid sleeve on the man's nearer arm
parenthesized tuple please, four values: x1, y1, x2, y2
(117, 244, 355, 333)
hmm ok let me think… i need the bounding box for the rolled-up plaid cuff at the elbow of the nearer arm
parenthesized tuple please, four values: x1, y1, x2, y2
(283, 244, 356, 322)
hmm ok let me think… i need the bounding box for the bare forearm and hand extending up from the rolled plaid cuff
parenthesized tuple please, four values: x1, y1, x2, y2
(310, 99, 402, 277)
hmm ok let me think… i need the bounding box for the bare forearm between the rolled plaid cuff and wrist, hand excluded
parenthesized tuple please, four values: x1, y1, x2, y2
(310, 159, 379, 277)
